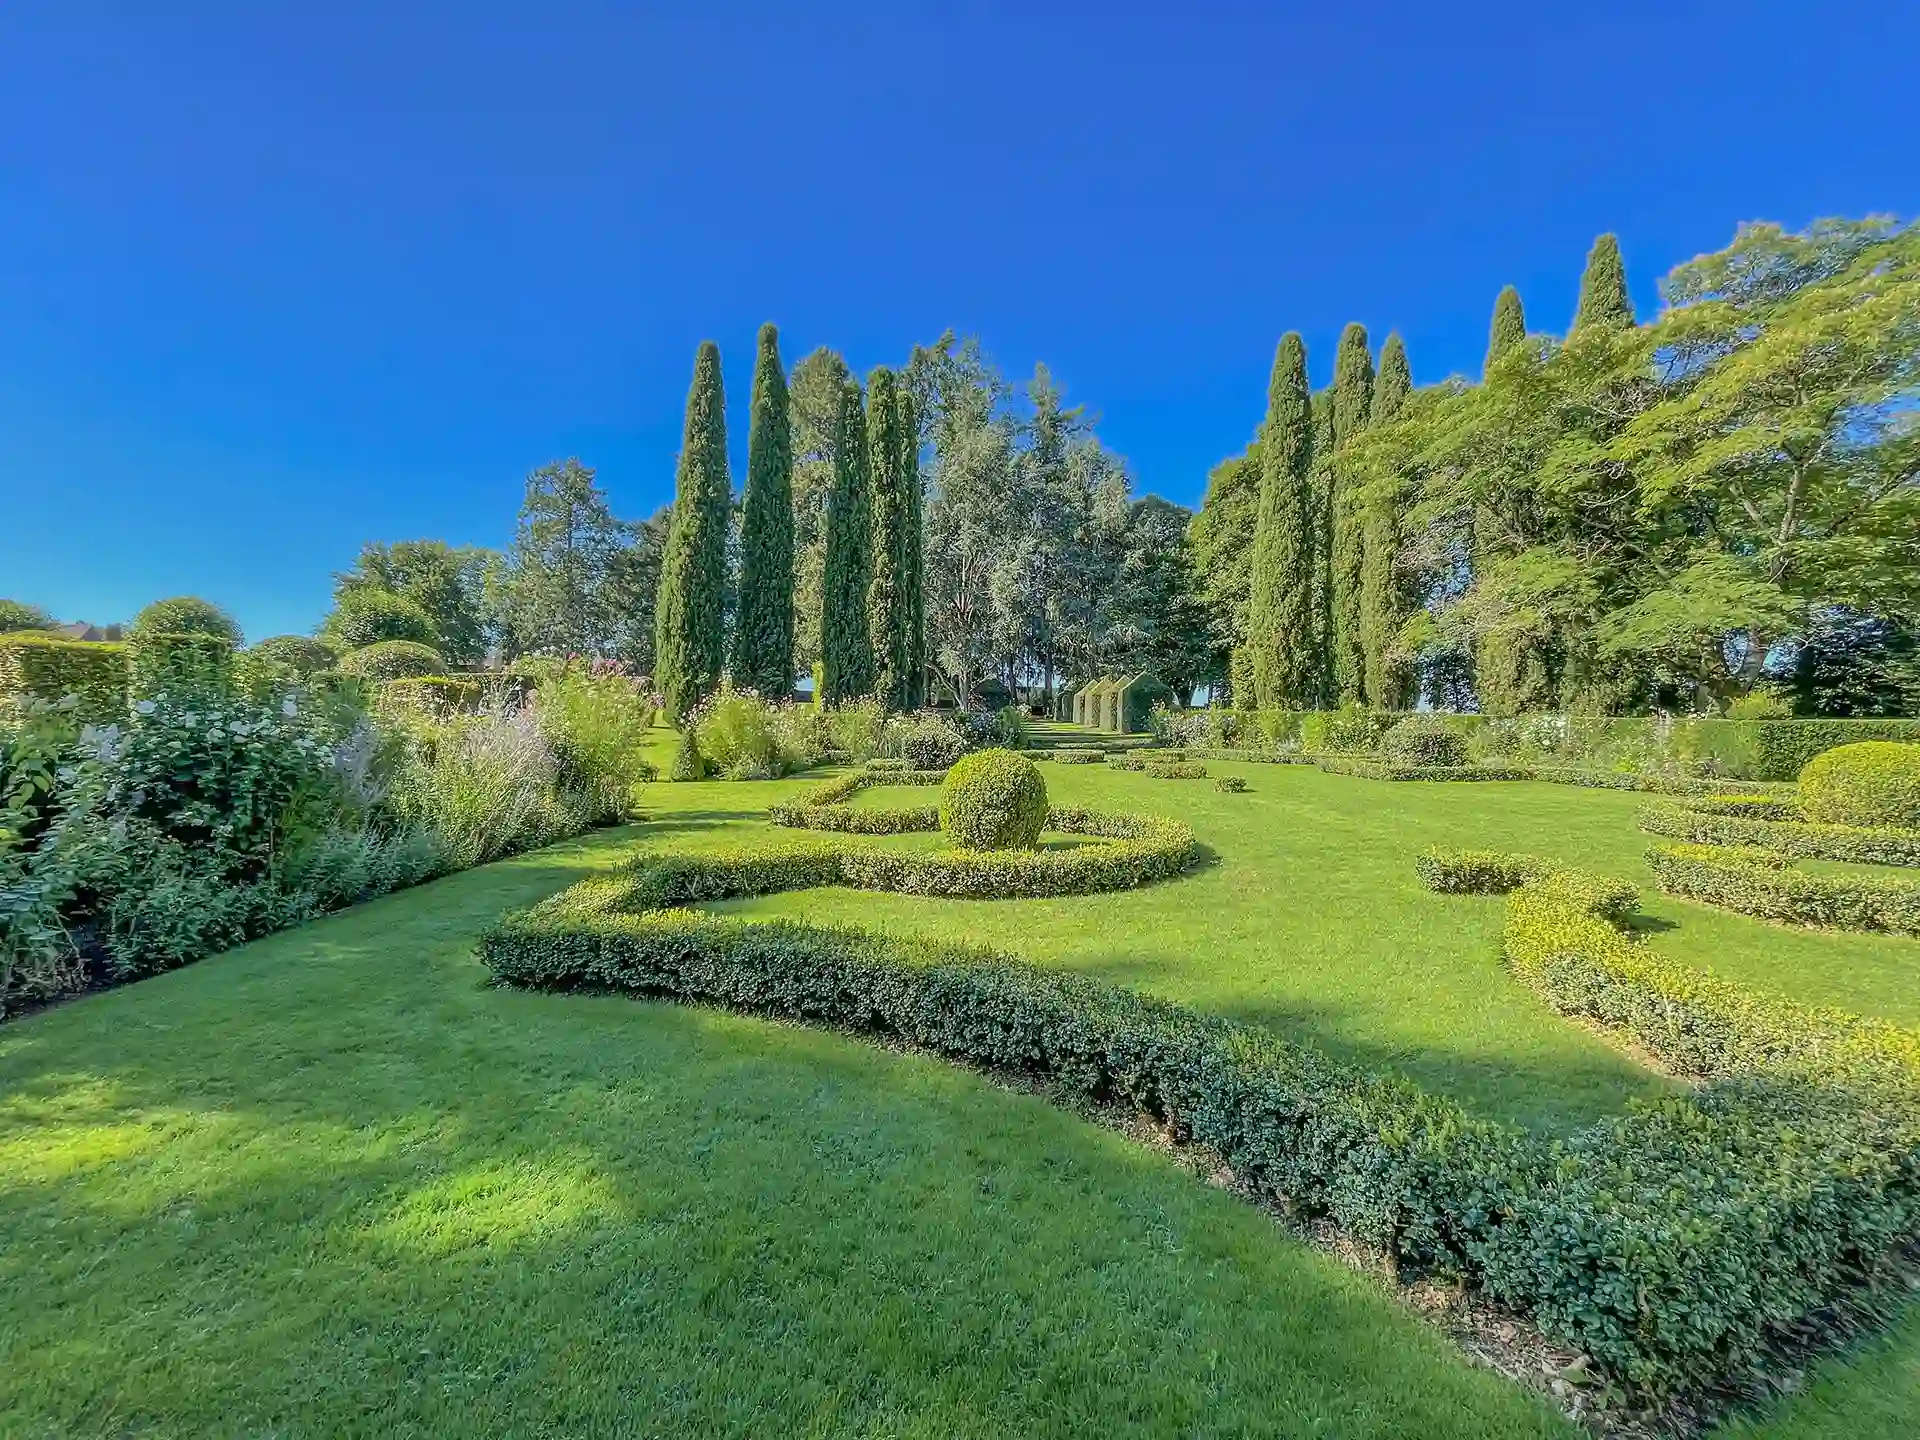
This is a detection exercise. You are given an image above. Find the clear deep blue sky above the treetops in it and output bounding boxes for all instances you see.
[0,0,1920,637]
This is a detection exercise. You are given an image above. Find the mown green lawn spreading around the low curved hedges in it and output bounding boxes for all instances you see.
[0,748,1920,1440]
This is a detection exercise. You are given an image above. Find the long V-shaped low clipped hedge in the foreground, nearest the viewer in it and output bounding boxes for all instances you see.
[482,847,1920,1396]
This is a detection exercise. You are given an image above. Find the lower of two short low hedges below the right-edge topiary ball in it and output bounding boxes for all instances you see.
[1647,845,1920,935]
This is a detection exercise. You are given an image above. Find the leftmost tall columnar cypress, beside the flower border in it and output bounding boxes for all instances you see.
[653,340,733,724]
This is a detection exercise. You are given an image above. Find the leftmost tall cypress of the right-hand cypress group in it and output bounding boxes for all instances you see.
[1246,330,1321,710]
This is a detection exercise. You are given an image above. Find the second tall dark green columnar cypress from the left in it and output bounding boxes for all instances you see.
[732,324,793,701]
